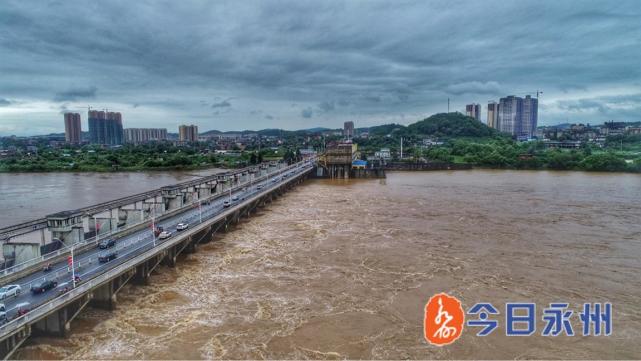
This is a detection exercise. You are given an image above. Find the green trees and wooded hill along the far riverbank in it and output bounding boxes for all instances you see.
[0,113,641,173]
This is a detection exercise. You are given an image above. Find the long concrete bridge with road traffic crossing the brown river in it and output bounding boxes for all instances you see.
[0,158,316,359]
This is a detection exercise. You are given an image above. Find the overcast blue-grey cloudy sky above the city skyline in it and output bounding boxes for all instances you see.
[0,0,641,135]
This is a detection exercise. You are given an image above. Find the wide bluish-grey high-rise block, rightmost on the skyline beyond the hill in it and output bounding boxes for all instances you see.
[498,95,539,138]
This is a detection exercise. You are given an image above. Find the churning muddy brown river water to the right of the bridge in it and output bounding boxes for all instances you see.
[8,170,641,359]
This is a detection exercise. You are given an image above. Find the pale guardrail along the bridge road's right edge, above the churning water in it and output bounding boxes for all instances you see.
[0,161,312,339]
